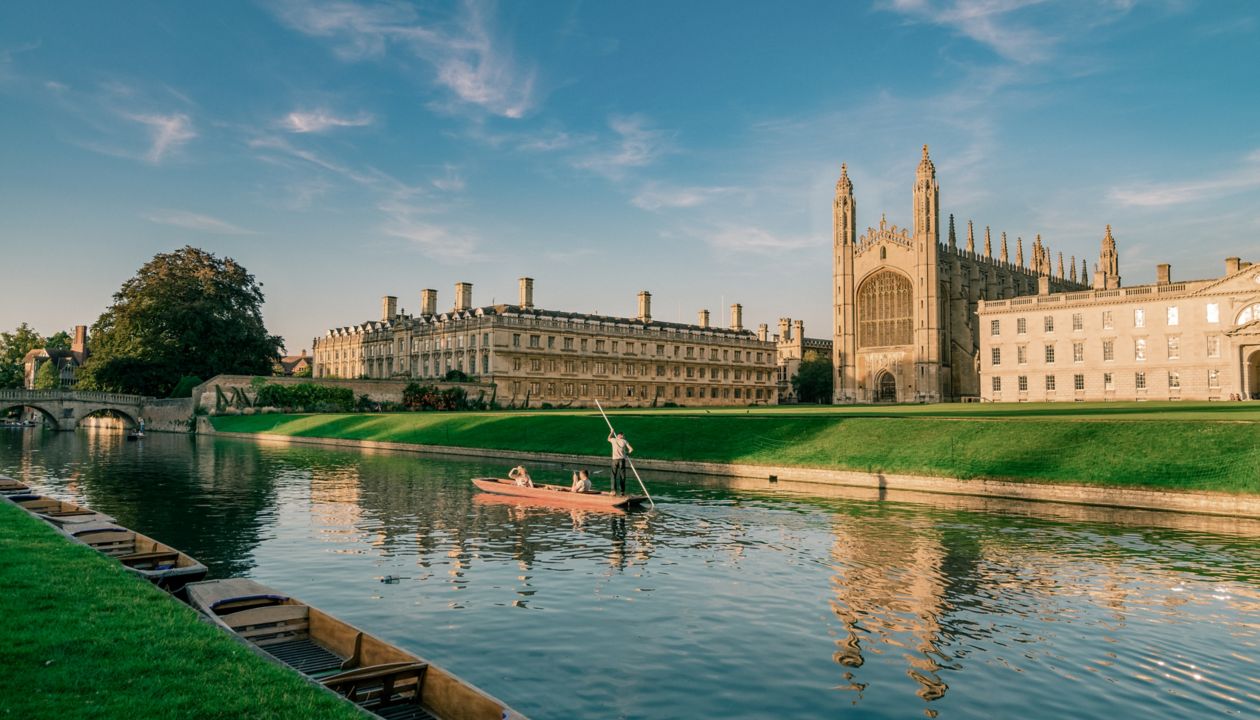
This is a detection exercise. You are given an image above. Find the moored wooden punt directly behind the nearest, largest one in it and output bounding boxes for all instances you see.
[62,522,205,593]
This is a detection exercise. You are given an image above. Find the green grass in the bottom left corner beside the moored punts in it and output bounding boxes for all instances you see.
[0,502,362,720]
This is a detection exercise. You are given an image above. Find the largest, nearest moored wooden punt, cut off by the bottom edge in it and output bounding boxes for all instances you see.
[186,578,524,720]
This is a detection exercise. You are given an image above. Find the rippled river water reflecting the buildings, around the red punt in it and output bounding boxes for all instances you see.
[0,430,1260,720]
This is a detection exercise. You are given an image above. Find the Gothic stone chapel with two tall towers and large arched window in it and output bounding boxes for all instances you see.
[833,145,1085,402]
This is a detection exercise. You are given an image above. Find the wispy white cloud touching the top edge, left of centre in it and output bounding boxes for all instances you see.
[276,0,536,117]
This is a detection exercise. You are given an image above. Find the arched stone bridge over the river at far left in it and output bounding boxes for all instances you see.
[0,390,193,430]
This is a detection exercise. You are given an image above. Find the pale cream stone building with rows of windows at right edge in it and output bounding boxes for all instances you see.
[979,250,1260,402]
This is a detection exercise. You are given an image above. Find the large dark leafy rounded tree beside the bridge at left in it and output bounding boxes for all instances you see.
[81,246,282,396]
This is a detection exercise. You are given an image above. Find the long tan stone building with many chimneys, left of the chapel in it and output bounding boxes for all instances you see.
[314,277,777,407]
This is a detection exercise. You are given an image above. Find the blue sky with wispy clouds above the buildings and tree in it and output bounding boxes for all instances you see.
[0,0,1260,353]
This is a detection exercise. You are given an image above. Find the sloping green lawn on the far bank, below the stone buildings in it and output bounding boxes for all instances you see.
[213,404,1260,493]
